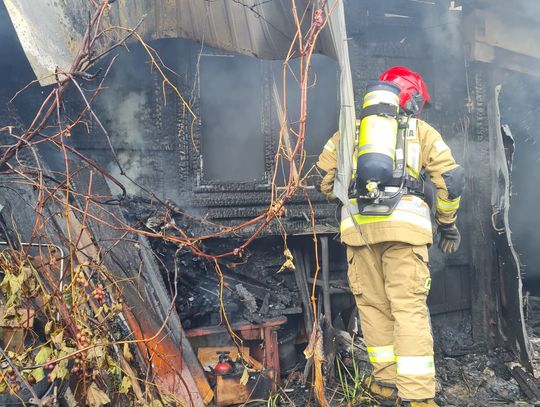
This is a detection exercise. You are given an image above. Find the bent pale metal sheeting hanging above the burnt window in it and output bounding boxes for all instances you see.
[4,0,336,85]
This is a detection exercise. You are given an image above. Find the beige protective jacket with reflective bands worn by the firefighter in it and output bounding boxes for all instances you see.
[317,119,464,246]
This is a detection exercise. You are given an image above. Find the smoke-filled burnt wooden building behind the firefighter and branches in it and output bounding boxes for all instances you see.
[0,0,540,406]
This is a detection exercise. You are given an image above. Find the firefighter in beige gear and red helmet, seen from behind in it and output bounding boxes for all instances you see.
[317,67,464,407]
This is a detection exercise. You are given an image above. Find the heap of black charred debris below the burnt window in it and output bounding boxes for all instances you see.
[125,197,302,329]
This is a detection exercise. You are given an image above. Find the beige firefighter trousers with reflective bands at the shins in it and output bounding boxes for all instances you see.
[347,242,435,400]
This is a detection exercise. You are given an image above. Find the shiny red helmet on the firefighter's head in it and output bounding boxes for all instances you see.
[379,66,431,115]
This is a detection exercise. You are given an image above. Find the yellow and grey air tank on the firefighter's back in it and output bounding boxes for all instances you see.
[356,81,400,191]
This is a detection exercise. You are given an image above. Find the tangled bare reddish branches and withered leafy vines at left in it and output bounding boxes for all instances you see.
[0,0,337,406]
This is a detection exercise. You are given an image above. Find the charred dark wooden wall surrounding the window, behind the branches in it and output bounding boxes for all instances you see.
[65,40,338,236]
